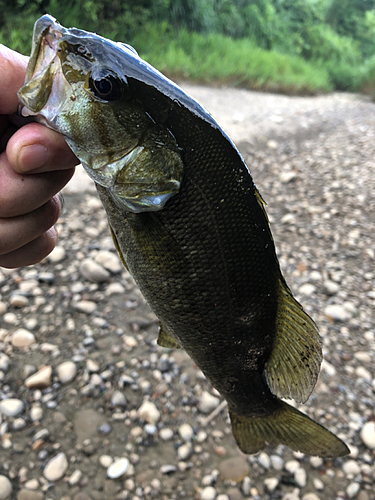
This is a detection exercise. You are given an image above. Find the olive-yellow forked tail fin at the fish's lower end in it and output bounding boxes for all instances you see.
[229,401,350,458]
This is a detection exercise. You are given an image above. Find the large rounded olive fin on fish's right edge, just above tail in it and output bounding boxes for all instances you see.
[265,279,322,403]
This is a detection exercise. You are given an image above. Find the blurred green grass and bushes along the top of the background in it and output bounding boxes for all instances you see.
[0,0,375,93]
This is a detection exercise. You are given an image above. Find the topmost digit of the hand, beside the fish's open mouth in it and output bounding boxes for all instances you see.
[0,44,28,115]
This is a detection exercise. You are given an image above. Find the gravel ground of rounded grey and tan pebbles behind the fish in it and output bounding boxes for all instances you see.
[0,85,375,500]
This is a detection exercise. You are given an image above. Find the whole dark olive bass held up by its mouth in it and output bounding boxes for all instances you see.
[18,15,349,457]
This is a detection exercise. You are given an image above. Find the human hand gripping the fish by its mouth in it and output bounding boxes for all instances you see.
[0,44,79,268]
